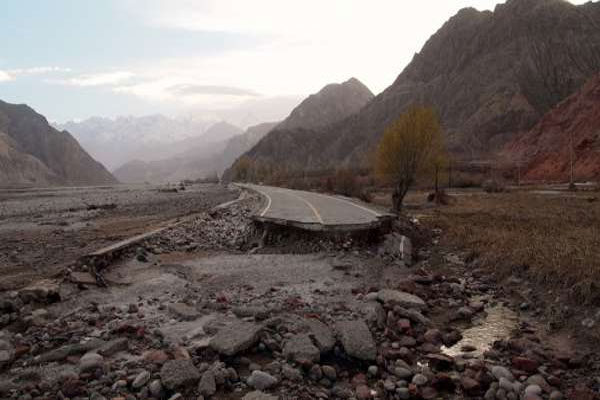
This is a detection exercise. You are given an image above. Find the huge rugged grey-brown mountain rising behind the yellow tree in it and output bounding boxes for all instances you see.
[233,0,600,170]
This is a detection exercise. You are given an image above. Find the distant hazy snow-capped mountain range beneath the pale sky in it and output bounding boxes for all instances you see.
[55,115,216,169]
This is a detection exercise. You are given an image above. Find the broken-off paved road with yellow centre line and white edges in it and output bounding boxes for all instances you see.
[241,185,389,228]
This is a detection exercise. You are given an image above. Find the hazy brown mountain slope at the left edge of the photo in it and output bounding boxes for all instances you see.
[0,101,117,186]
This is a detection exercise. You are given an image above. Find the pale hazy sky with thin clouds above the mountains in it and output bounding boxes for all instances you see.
[0,0,585,121]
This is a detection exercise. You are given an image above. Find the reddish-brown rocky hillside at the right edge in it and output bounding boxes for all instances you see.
[506,74,600,181]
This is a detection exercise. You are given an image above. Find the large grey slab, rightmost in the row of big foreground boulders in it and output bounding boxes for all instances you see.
[335,320,377,361]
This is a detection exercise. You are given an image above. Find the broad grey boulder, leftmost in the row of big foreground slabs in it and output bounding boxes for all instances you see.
[209,321,262,356]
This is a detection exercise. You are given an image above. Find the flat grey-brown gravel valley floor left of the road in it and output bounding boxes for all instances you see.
[0,185,235,291]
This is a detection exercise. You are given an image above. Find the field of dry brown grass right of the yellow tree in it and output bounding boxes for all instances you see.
[424,192,600,304]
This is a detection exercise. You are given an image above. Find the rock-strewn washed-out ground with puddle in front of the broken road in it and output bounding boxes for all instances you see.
[0,188,600,400]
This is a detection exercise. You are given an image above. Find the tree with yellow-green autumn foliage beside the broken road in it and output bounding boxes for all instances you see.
[375,106,445,213]
